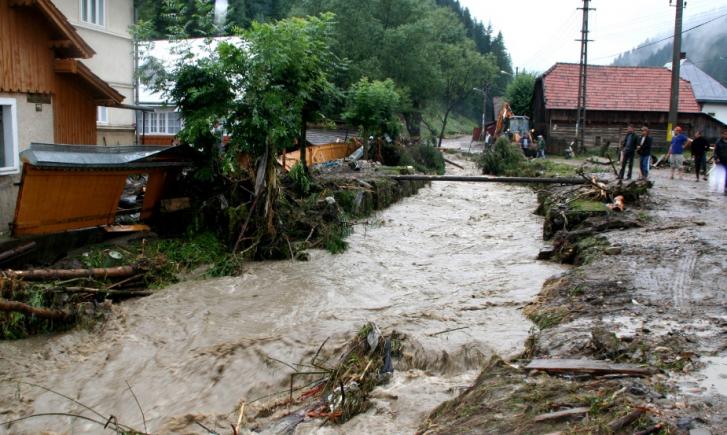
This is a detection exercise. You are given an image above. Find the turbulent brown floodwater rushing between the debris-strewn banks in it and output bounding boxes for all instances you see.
[0,158,562,433]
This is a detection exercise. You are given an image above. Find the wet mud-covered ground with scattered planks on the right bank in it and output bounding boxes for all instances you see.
[420,145,727,434]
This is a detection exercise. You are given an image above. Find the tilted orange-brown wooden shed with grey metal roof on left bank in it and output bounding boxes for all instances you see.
[12,143,192,236]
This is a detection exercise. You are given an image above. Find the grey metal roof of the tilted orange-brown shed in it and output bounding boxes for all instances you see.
[20,143,191,169]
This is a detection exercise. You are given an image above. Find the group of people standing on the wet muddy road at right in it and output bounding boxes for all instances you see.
[618,125,727,194]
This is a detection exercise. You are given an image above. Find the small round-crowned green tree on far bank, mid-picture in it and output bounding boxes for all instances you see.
[343,77,401,159]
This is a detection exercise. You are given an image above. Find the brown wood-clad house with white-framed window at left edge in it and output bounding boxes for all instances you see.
[0,0,124,236]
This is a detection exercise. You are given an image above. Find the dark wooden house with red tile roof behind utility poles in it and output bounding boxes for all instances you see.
[533,63,722,153]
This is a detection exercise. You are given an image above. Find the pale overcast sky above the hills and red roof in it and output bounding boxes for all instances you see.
[459,0,727,72]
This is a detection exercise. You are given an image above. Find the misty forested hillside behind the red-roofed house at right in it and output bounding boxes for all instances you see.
[614,16,727,86]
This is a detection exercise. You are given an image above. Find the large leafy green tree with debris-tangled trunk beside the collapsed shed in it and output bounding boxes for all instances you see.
[169,15,339,258]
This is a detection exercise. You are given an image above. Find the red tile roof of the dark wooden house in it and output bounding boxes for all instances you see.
[541,63,700,113]
